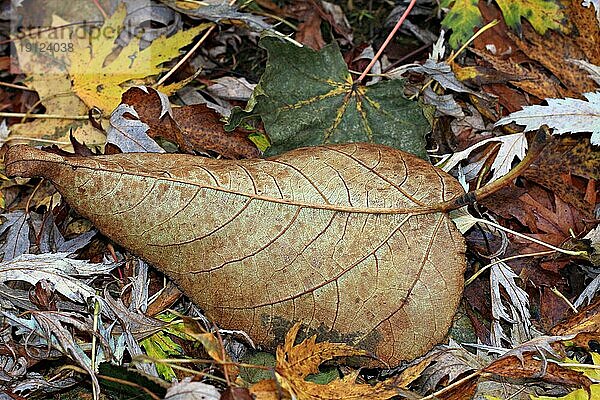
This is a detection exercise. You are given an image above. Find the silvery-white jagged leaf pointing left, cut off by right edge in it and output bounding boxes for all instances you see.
[495,92,600,145]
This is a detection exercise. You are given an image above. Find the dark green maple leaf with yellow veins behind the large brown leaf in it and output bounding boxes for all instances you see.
[228,37,429,158]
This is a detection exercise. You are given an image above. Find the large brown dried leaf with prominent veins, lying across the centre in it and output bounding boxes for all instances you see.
[6,144,465,364]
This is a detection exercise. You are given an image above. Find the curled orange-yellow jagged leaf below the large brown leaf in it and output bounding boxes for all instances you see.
[250,324,399,400]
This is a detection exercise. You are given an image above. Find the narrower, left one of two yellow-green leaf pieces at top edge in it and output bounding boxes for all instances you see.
[440,0,483,49]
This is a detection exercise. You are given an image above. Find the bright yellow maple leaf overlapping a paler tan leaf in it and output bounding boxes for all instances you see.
[69,5,212,113]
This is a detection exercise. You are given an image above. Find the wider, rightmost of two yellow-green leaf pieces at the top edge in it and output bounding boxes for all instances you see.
[496,0,565,35]
